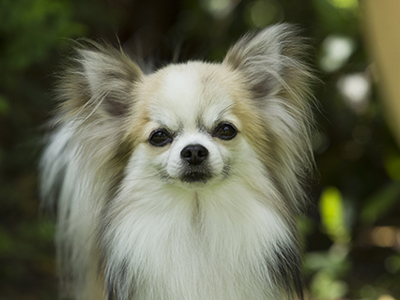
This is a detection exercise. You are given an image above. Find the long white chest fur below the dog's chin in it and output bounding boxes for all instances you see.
[103,178,291,300]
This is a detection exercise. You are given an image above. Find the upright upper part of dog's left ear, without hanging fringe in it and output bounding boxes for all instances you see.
[59,42,143,118]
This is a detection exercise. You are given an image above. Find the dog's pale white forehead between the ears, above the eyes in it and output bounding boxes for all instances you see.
[142,62,233,129]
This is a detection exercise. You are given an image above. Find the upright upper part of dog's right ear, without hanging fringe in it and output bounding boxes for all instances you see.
[224,24,312,98]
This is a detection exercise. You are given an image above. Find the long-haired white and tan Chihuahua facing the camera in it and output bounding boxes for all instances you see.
[41,24,313,300]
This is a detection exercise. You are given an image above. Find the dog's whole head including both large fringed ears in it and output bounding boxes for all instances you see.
[57,25,311,206]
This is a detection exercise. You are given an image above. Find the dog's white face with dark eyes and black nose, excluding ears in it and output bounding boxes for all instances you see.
[133,62,256,189]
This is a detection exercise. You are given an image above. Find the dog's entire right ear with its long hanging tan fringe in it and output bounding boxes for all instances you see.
[223,24,314,210]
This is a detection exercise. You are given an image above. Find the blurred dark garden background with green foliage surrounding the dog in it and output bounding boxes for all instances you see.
[0,0,400,300]
